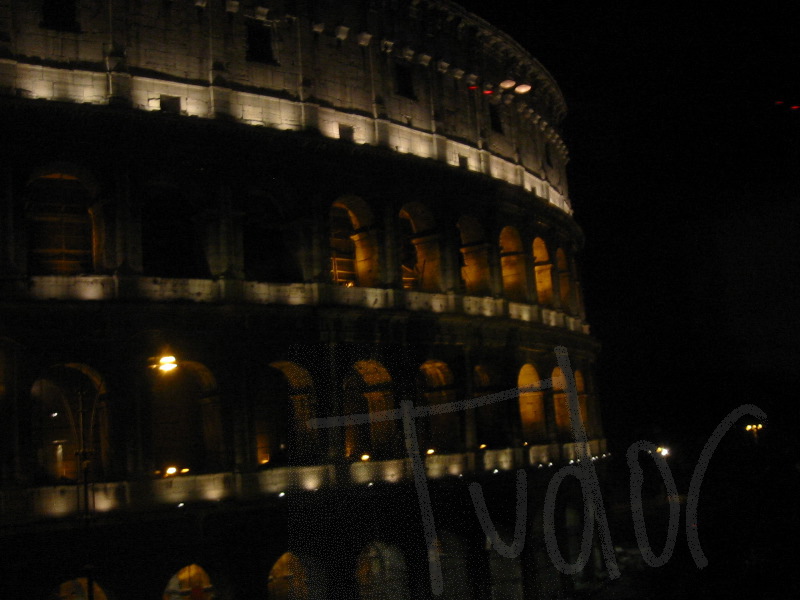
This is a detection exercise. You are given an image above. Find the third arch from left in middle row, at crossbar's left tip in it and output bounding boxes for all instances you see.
[252,361,319,466]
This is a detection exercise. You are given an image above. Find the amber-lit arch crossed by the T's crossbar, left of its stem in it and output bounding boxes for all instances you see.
[344,360,398,460]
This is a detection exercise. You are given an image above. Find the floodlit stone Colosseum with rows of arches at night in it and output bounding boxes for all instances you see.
[0,0,607,600]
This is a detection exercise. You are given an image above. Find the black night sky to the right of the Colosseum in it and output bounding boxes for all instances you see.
[461,0,800,444]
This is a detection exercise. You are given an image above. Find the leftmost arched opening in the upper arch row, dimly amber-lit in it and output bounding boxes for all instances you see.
[25,172,97,275]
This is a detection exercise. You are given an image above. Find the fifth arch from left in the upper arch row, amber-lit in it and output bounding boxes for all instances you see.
[399,202,441,292]
